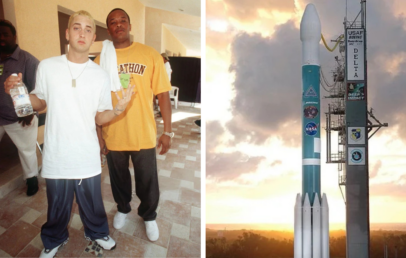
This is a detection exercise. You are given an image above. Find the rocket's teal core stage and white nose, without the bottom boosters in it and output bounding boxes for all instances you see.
[300,1,321,205]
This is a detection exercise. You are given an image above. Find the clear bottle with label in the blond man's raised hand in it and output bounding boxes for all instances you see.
[10,73,34,117]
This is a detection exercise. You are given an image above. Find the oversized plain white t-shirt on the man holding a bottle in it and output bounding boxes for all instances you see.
[31,55,112,179]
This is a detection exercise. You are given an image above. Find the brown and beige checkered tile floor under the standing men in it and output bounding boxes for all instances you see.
[0,106,201,257]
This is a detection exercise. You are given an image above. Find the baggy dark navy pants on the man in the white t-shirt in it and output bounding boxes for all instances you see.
[41,175,109,249]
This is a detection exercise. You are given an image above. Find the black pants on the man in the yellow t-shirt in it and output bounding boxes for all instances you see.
[107,148,159,221]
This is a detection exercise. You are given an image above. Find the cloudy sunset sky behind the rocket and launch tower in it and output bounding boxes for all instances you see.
[205,0,406,229]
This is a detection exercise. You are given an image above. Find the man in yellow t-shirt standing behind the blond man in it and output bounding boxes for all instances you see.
[95,8,174,241]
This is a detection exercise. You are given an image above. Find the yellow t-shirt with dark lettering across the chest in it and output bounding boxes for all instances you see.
[95,42,171,151]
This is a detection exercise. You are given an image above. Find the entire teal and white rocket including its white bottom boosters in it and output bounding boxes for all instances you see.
[294,4,330,258]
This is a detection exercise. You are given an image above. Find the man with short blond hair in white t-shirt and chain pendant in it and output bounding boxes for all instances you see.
[5,11,134,257]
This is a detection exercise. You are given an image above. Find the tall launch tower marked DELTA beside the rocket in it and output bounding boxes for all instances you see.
[320,0,388,258]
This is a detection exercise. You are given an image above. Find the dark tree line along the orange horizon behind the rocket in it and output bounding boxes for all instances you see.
[206,229,406,258]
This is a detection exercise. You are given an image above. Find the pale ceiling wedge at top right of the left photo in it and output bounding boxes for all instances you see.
[139,0,201,17]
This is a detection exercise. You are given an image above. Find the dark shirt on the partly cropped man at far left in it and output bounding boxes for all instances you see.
[0,46,39,126]
